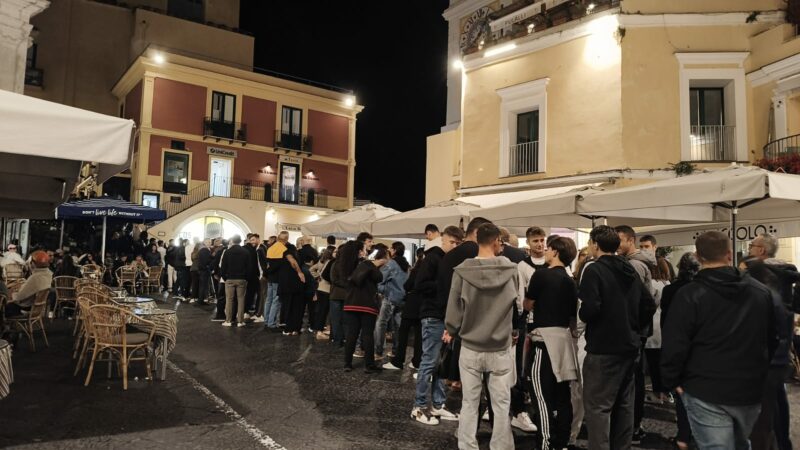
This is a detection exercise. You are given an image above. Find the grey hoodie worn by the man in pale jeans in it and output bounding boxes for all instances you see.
[445,256,519,352]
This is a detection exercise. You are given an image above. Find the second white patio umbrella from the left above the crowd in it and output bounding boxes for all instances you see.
[372,200,478,239]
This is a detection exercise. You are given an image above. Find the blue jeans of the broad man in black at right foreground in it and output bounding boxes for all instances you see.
[681,392,761,450]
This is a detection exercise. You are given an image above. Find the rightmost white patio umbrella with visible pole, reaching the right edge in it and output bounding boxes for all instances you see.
[579,166,800,264]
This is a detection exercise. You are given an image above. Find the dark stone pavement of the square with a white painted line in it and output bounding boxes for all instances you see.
[0,298,800,450]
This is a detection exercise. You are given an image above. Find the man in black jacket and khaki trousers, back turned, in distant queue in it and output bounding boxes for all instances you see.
[220,234,250,327]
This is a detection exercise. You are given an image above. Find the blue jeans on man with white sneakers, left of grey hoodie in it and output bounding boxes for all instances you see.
[414,317,447,408]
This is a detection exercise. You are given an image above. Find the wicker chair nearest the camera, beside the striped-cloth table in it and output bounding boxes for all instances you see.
[84,305,155,390]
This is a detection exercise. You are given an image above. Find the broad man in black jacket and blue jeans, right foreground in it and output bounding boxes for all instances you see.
[661,231,777,449]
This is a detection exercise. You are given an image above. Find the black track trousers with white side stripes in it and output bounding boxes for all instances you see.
[531,342,572,450]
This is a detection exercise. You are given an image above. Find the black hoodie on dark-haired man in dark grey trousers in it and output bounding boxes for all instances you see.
[578,255,656,357]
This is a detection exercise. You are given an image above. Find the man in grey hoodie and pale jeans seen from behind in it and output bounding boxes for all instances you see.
[443,223,519,450]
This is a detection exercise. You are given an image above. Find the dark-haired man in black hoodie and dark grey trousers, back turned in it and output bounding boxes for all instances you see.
[578,225,656,449]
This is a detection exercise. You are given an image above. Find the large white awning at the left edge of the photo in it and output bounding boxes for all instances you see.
[0,90,134,219]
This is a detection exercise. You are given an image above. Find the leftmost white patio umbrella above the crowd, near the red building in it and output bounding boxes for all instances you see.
[300,203,399,238]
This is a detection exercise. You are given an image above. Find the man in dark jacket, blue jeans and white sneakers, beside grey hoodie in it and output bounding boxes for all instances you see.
[411,226,464,425]
